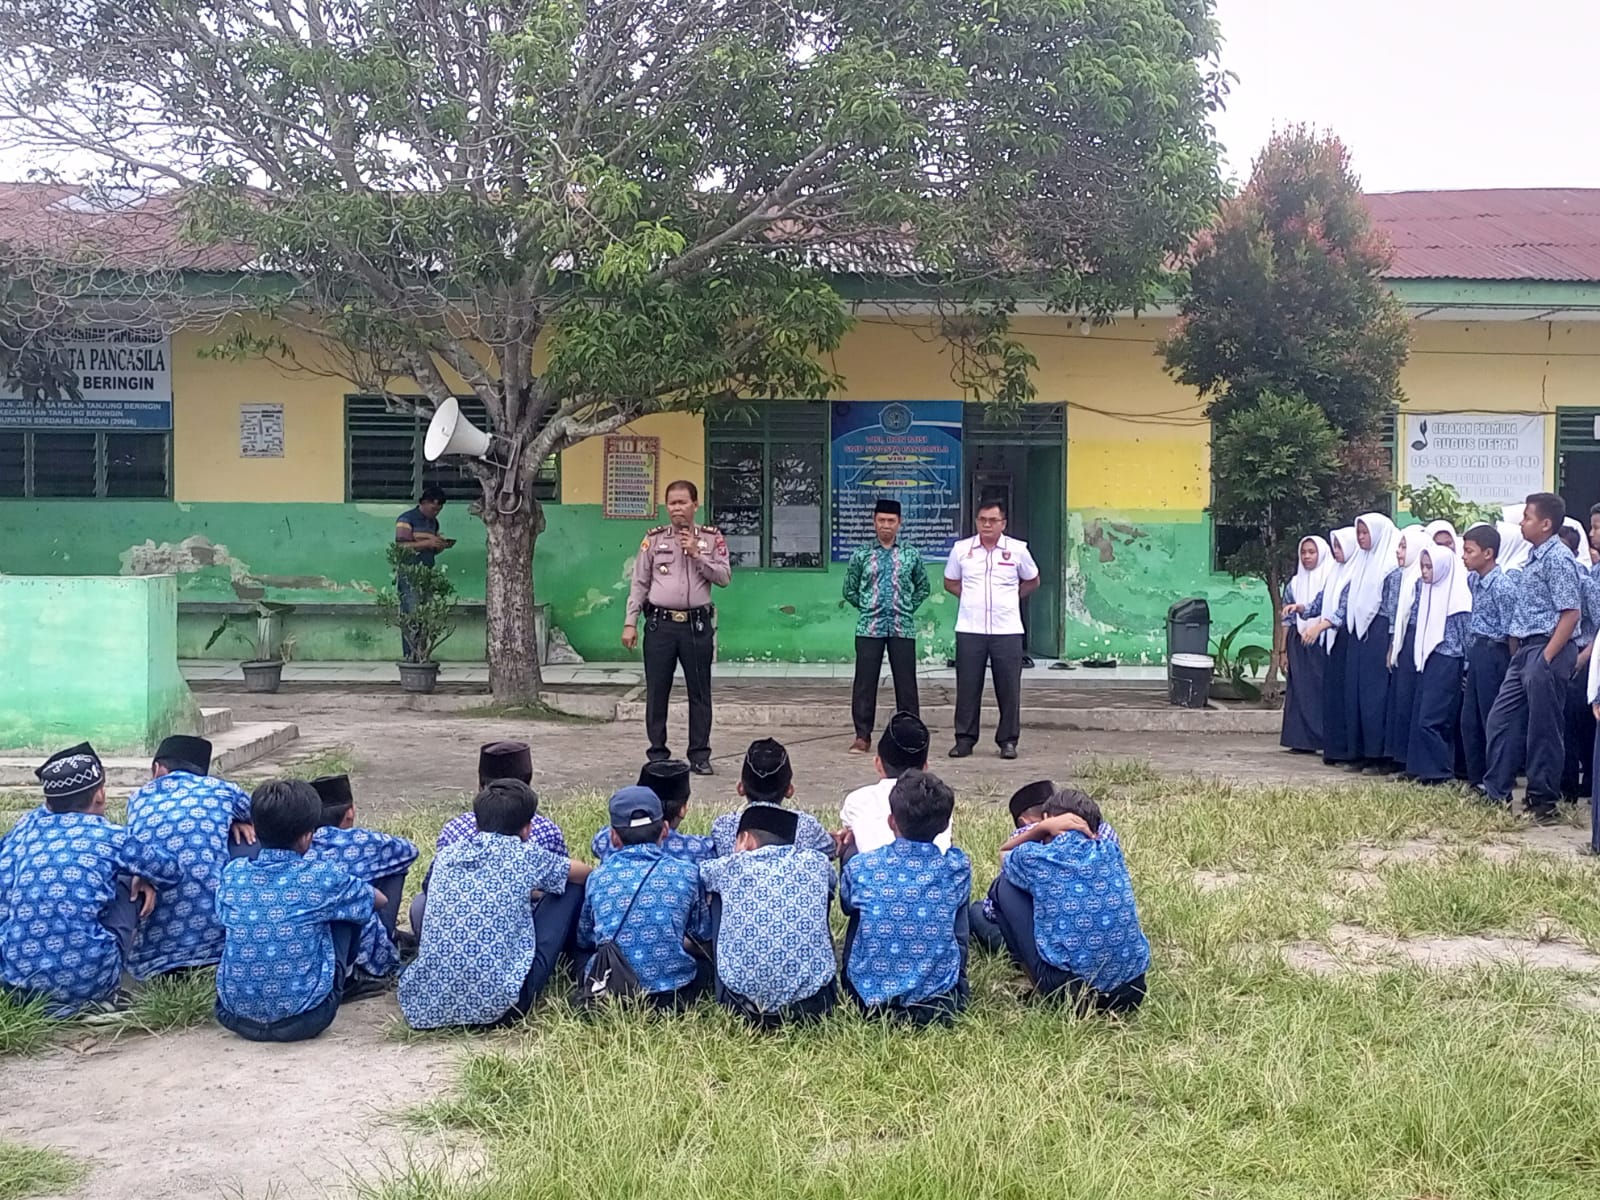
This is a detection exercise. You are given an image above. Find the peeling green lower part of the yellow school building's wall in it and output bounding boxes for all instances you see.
[0,501,1267,662]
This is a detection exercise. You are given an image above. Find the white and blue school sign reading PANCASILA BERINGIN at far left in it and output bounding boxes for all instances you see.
[0,330,173,429]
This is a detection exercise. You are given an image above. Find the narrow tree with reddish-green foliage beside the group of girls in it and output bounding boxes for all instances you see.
[1162,128,1408,683]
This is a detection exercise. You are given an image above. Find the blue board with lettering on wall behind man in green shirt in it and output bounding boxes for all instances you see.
[829,400,962,563]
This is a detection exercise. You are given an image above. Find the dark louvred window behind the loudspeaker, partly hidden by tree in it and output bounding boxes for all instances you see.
[344,395,562,504]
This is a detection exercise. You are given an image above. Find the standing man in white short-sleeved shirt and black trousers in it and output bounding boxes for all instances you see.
[944,501,1038,758]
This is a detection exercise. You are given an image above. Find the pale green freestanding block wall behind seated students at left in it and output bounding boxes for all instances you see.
[0,576,200,754]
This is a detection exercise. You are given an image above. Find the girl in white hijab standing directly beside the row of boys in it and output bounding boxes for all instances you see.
[1406,546,1472,784]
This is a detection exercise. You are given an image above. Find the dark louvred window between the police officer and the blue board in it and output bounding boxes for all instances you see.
[706,400,829,570]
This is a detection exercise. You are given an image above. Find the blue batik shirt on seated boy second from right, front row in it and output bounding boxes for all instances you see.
[838,837,973,1005]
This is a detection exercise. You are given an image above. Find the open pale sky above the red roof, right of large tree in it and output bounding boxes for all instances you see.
[1216,0,1600,192]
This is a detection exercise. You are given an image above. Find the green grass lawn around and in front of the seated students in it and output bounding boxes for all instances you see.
[9,763,1600,1200]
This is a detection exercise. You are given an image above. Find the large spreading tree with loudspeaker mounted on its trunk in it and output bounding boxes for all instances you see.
[0,0,1224,701]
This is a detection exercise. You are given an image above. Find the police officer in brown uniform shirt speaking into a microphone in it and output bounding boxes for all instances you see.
[622,480,733,774]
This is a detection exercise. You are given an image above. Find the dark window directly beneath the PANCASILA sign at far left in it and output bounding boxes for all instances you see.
[0,429,173,499]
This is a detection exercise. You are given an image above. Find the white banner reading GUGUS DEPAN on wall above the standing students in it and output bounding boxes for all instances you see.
[1405,413,1546,504]
